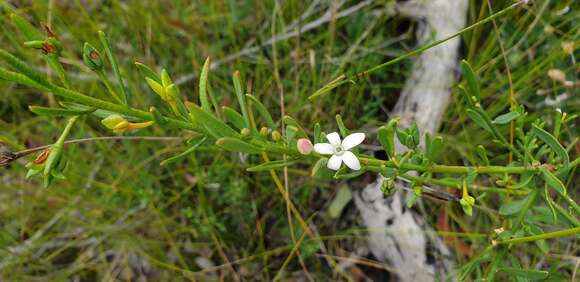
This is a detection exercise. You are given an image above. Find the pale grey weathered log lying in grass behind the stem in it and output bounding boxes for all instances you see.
[355,0,467,281]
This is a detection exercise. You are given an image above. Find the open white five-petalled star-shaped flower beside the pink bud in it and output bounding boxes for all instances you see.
[314,132,365,170]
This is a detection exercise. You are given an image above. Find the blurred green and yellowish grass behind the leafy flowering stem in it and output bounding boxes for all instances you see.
[0,0,580,281]
